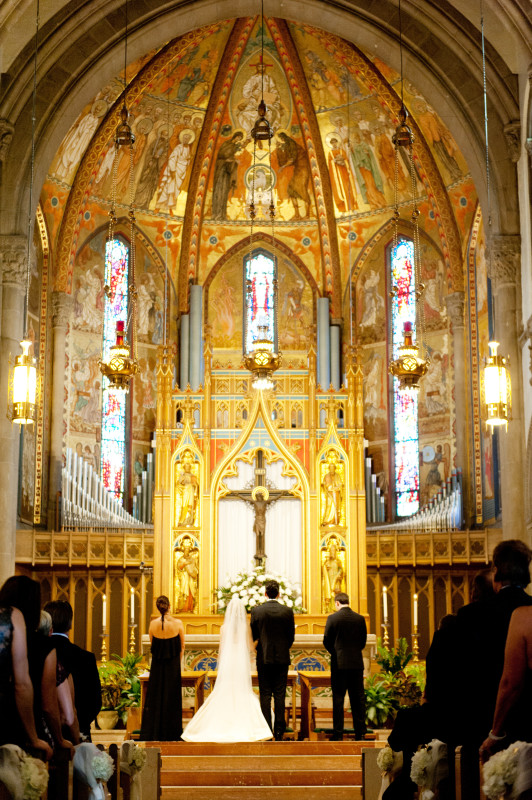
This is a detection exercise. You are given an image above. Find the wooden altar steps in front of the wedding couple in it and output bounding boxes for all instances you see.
[147,741,378,800]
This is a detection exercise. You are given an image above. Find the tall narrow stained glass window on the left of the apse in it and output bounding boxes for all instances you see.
[101,239,129,500]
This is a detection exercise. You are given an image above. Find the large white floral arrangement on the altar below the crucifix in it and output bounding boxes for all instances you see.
[217,567,306,614]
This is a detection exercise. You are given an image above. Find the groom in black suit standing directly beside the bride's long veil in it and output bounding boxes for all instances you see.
[251,581,295,741]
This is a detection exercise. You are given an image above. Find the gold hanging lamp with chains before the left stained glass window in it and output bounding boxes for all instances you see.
[98,0,139,392]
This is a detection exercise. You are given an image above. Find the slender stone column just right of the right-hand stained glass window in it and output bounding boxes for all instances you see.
[445,292,473,528]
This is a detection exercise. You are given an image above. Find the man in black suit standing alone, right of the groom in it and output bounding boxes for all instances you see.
[323,592,367,741]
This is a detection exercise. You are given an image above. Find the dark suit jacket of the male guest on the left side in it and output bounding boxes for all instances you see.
[52,634,102,736]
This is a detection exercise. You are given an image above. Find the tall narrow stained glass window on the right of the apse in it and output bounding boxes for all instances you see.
[390,239,419,517]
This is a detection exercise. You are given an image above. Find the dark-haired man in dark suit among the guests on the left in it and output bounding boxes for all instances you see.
[45,600,102,741]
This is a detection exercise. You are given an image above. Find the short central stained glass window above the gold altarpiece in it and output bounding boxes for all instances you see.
[245,252,275,353]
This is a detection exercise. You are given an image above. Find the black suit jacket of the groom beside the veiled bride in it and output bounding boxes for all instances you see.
[251,600,296,666]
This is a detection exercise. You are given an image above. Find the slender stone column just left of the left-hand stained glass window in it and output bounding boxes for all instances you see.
[48,292,72,531]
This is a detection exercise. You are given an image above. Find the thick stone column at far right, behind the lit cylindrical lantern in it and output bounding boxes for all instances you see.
[488,235,526,539]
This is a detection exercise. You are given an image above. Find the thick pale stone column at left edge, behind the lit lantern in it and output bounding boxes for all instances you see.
[0,235,27,585]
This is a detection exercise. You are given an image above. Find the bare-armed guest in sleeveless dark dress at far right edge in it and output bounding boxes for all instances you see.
[480,606,532,761]
